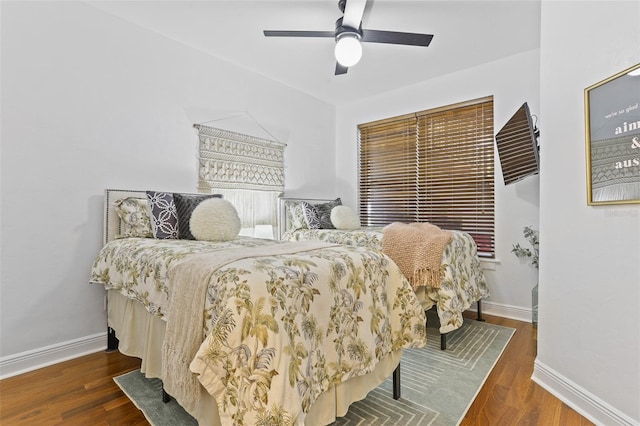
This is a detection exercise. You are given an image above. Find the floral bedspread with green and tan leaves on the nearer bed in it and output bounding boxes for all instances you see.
[90,238,426,425]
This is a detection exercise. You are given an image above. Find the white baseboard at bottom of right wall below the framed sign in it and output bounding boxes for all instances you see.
[531,359,640,426]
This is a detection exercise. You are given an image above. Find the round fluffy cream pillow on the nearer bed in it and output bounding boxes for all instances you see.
[189,198,241,241]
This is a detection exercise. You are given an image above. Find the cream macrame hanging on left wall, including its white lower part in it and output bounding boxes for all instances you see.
[193,124,286,228]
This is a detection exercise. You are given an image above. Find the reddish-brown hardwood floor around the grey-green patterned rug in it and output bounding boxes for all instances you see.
[0,312,592,426]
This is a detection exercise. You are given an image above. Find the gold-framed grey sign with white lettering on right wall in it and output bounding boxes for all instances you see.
[584,64,640,205]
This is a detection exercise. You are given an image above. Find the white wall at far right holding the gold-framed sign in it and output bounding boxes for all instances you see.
[534,1,640,425]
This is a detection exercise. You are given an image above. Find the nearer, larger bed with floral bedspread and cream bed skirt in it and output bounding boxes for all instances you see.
[89,189,426,425]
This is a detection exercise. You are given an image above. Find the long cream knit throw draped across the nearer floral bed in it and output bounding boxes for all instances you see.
[162,241,336,414]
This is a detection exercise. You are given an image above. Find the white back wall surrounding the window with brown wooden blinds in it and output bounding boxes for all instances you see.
[336,49,546,321]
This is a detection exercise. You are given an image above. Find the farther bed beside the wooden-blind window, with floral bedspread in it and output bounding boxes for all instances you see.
[278,197,489,349]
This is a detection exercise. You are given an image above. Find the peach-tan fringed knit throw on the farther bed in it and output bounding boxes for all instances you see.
[382,222,453,289]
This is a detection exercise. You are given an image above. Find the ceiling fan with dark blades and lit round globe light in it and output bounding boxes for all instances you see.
[264,0,433,75]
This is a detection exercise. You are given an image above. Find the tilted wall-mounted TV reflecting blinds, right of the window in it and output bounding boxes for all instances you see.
[496,102,540,185]
